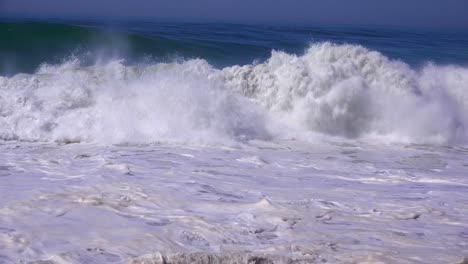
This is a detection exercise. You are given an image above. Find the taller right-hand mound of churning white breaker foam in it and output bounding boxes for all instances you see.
[224,43,468,144]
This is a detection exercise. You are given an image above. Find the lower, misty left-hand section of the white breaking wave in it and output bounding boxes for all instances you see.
[0,60,268,143]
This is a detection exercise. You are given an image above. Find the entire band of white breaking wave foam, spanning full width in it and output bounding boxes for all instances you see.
[0,43,468,145]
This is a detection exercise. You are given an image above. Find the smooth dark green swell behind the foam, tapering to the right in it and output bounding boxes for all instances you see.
[0,21,249,75]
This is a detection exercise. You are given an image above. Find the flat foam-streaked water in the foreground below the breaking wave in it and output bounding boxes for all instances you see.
[0,141,468,263]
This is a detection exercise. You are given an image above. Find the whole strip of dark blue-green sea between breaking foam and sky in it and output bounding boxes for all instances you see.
[0,19,468,74]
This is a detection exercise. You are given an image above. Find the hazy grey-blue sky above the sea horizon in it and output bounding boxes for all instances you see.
[0,0,468,28]
